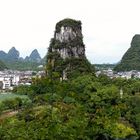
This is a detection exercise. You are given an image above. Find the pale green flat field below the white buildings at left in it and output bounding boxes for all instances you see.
[0,93,29,102]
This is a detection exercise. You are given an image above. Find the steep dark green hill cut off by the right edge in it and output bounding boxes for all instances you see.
[114,34,140,71]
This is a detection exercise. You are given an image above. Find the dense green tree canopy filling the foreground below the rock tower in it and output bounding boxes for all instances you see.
[0,75,140,140]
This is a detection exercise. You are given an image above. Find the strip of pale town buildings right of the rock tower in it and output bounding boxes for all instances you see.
[96,69,140,79]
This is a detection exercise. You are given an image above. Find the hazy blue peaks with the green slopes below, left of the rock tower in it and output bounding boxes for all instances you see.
[0,47,45,70]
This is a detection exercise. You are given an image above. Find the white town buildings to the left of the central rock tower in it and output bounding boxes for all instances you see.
[0,70,44,90]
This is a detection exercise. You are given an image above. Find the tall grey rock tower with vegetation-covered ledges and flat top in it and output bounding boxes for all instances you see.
[47,19,91,79]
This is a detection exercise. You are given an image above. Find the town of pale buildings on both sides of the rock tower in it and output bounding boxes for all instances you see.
[0,68,140,91]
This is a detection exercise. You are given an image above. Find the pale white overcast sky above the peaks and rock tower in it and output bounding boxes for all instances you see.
[0,0,140,64]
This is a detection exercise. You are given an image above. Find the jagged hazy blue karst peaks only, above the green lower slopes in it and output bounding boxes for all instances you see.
[0,47,42,63]
